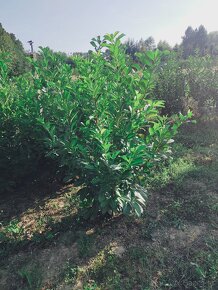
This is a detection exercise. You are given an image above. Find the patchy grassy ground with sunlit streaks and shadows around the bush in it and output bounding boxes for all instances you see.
[0,121,218,290]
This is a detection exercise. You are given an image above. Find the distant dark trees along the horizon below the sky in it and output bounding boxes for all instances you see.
[0,23,218,75]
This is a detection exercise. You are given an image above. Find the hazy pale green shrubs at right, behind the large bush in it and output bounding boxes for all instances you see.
[154,53,218,117]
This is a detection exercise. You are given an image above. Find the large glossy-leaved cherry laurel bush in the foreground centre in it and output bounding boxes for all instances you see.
[38,32,191,217]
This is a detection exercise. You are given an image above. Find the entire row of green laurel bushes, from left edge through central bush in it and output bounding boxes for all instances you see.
[0,33,190,216]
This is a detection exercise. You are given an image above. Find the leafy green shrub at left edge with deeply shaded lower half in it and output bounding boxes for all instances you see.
[0,50,57,191]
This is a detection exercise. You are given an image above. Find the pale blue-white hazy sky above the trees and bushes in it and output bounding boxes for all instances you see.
[0,0,218,53]
